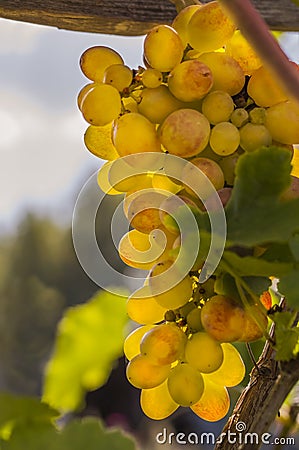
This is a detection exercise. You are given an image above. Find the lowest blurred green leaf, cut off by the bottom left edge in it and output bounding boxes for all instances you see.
[3,419,136,450]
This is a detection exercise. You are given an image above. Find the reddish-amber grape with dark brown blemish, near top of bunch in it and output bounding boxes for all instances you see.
[168,59,213,102]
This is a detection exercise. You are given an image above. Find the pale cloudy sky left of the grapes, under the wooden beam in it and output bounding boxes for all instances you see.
[0,19,299,231]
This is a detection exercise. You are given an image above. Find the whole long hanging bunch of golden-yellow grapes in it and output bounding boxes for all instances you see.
[78,1,299,421]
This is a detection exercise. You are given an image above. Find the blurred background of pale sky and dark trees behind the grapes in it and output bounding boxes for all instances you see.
[0,19,299,449]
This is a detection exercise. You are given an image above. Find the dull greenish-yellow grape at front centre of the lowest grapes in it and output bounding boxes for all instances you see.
[167,363,204,406]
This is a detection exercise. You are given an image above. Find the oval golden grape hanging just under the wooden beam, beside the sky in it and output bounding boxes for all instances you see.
[144,25,184,72]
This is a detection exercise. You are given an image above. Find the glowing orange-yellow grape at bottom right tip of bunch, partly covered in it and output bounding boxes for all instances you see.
[191,375,230,422]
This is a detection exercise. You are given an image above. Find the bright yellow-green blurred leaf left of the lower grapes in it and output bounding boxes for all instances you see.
[43,291,127,411]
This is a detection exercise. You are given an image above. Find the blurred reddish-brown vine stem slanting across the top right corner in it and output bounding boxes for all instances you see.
[219,0,299,104]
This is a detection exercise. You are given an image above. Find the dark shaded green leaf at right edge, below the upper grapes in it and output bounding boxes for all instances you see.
[226,146,299,246]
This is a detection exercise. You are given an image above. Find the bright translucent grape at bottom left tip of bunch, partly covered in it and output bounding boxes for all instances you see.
[140,381,179,420]
